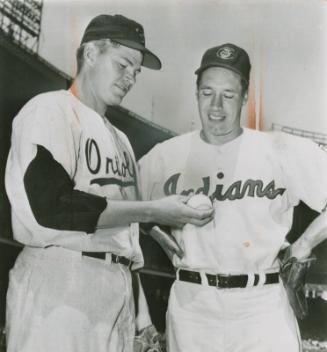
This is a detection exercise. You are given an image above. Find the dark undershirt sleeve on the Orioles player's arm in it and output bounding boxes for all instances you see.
[24,145,107,233]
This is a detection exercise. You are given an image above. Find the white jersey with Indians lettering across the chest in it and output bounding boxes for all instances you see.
[139,128,327,274]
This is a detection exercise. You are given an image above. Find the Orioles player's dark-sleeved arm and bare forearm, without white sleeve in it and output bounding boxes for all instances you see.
[24,146,213,233]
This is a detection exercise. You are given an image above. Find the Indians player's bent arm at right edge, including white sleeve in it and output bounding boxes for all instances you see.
[276,134,327,259]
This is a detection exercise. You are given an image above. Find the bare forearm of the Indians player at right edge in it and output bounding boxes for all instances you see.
[291,208,327,259]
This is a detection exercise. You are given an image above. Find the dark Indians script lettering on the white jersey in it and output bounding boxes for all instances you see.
[164,172,285,201]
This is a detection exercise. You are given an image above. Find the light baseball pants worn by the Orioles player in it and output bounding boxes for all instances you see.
[6,247,135,352]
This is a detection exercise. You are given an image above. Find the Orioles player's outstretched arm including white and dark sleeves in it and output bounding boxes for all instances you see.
[19,103,212,233]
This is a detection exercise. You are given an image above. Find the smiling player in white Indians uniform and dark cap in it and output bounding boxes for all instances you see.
[139,44,327,352]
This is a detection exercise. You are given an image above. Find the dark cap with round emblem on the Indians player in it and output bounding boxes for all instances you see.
[195,43,251,83]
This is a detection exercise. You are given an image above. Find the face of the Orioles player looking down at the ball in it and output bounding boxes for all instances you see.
[85,43,142,110]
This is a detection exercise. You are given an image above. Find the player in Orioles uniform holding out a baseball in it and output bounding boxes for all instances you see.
[6,15,212,352]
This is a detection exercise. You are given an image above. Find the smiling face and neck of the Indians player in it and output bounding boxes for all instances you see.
[197,67,247,144]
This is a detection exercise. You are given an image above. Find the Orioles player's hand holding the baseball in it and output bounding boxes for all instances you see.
[152,195,214,228]
